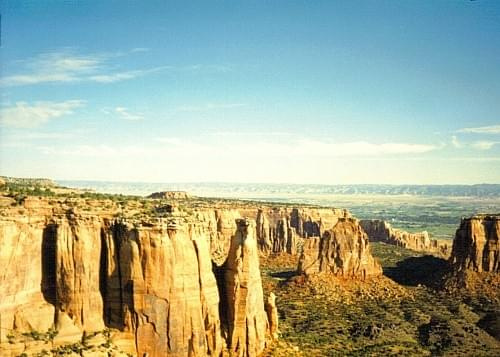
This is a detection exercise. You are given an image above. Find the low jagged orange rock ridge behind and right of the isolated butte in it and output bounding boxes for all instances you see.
[360,219,451,258]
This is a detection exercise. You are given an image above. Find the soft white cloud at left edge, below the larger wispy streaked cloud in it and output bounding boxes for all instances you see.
[0,100,85,128]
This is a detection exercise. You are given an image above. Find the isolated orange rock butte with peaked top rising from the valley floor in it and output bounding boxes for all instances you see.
[297,218,382,279]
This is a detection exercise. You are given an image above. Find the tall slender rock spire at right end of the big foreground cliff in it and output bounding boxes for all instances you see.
[224,219,268,357]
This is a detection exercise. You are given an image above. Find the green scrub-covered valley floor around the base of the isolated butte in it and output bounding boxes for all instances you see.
[262,243,500,356]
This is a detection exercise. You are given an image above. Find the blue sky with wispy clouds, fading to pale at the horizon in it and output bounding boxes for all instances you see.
[0,0,500,184]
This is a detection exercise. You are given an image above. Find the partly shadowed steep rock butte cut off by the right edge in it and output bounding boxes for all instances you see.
[450,214,500,273]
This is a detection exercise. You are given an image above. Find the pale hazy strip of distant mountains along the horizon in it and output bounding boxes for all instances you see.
[57,180,500,198]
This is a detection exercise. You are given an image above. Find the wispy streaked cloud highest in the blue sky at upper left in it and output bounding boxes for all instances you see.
[0,49,172,87]
